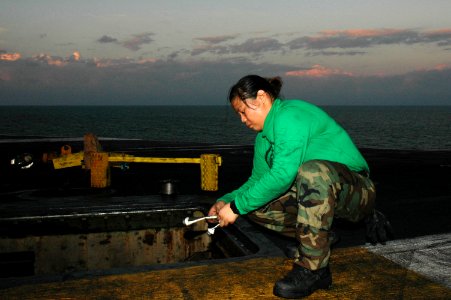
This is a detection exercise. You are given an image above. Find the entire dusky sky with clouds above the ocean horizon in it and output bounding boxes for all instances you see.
[0,0,451,105]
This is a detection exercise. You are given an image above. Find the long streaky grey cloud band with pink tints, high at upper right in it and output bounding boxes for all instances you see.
[187,28,451,57]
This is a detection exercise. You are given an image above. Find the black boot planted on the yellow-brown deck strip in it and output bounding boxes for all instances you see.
[273,264,332,298]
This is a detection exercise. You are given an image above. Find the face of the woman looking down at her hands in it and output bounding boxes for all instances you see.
[231,91,272,131]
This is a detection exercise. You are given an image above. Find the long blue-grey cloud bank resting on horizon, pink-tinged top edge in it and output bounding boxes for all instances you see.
[0,52,451,105]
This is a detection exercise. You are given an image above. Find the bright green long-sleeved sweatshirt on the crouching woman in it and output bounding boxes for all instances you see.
[218,99,369,214]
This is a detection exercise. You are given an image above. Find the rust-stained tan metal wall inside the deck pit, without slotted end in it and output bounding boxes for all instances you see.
[0,224,212,276]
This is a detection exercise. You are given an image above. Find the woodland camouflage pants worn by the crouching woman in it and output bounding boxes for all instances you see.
[248,160,376,270]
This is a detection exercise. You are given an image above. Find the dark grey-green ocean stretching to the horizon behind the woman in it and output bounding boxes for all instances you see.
[0,106,451,150]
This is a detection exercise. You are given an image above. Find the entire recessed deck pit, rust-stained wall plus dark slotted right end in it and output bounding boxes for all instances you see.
[0,216,283,289]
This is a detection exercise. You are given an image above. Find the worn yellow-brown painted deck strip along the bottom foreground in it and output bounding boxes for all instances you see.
[0,247,451,299]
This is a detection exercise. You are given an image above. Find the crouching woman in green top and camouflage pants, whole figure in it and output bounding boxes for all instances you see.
[209,75,386,297]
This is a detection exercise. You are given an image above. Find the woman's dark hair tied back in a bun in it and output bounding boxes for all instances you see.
[229,75,282,102]
